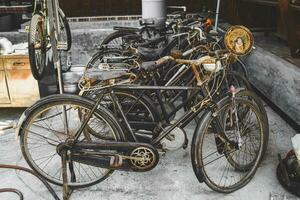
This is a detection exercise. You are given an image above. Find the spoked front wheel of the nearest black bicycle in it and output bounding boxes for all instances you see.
[192,97,266,193]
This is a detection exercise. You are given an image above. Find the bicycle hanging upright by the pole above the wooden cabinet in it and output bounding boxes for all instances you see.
[28,0,72,80]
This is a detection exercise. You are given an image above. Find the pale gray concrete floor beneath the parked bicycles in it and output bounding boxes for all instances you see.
[0,107,296,200]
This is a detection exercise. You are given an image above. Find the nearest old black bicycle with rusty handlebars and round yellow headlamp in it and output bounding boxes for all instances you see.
[17,27,268,198]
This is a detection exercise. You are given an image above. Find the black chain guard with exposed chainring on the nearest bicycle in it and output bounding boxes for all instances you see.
[57,141,159,172]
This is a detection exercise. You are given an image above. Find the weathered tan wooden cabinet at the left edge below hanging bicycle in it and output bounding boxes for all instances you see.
[0,55,40,107]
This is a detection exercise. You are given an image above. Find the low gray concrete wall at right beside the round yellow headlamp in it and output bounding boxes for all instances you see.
[246,47,300,125]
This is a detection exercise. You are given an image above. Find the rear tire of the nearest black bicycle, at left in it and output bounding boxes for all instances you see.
[19,94,125,189]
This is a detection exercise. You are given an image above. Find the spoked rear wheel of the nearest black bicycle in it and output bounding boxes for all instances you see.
[20,95,122,188]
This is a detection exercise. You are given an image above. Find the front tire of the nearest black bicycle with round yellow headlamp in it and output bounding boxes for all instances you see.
[191,97,265,193]
